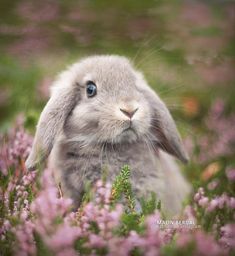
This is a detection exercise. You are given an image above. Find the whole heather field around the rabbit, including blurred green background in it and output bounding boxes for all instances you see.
[0,0,235,256]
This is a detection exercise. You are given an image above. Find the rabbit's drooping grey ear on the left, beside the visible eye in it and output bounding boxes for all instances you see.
[25,72,79,170]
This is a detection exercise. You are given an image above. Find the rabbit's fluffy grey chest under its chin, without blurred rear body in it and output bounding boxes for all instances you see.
[50,135,165,204]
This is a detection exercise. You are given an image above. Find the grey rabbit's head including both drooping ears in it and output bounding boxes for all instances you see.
[26,56,187,169]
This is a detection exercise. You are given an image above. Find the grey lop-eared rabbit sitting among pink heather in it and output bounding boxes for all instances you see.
[26,55,191,215]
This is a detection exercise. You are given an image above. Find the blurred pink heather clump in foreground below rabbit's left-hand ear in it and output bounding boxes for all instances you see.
[26,169,81,255]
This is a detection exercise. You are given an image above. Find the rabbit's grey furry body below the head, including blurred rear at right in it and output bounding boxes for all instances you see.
[50,134,191,215]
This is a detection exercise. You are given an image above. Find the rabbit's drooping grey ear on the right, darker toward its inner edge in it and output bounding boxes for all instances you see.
[138,74,189,163]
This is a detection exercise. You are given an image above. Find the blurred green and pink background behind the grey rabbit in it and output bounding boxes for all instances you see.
[0,0,235,180]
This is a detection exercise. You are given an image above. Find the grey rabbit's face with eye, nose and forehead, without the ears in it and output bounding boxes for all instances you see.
[65,56,151,144]
